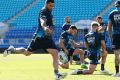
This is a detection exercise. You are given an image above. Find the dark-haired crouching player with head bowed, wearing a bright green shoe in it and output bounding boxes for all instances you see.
[59,25,87,69]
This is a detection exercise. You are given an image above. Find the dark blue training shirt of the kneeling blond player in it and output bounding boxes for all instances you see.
[85,31,104,56]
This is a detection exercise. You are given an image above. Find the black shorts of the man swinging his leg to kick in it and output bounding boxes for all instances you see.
[27,36,57,52]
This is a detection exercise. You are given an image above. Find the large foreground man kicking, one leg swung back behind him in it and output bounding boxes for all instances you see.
[3,0,67,80]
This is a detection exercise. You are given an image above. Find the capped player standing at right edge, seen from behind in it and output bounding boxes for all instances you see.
[107,0,120,77]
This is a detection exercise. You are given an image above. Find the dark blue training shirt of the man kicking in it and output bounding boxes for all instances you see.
[37,7,54,38]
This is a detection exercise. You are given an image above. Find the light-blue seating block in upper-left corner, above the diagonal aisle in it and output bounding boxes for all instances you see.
[0,0,32,22]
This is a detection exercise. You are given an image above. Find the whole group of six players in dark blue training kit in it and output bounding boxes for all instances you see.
[1,0,120,80]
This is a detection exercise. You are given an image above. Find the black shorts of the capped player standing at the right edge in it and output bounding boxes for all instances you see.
[112,34,120,49]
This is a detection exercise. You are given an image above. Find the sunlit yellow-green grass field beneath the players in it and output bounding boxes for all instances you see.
[0,54,120,80]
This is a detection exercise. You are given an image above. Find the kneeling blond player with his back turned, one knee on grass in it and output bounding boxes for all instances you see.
[71,22,106,75]
